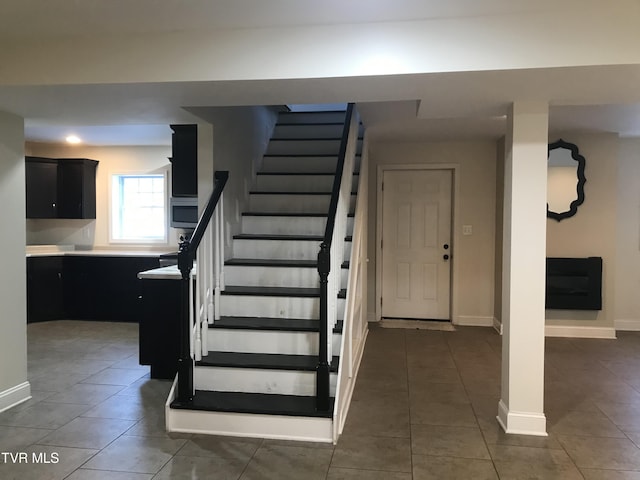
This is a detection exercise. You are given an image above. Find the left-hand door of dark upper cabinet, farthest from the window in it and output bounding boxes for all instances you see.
[25,157,58,218]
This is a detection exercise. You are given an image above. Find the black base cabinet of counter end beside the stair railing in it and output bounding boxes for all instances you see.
[139,279,181,380]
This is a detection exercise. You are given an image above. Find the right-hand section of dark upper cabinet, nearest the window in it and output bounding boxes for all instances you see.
[58,159,98,218]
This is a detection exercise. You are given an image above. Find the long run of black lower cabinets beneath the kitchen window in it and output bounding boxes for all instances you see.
[27,255,159,322]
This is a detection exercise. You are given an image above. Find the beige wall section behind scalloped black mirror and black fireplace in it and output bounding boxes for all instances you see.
[546,132,620,329]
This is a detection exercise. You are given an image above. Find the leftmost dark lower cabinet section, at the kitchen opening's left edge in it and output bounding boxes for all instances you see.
[27,256,65,323]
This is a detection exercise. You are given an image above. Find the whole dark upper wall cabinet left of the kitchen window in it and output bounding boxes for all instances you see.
[25,157,98,218]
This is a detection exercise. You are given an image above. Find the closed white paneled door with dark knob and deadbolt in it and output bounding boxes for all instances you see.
[381,170,452,320]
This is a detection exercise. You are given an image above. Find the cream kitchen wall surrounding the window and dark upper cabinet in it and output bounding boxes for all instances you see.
[26,140,181,250]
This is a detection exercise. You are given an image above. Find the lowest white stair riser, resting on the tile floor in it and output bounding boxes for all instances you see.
[165,408,333,443]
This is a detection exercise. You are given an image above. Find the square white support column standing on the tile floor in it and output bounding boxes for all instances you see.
[498,102,549,436]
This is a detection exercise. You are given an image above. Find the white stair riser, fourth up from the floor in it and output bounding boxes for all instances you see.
[220,295,344,319]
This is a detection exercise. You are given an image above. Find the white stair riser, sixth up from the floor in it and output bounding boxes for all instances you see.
[233,238,351,260]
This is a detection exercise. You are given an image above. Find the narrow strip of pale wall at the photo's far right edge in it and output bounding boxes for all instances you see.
[615,138,640,330]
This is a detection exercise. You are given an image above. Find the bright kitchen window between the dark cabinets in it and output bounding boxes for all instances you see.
[110,174,167,243]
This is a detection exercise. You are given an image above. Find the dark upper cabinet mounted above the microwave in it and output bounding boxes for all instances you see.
[169,125,198,197]
